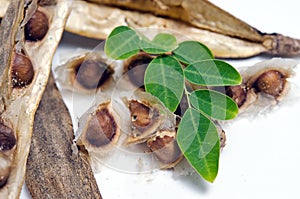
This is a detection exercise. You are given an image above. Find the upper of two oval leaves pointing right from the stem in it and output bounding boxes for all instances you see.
[184,59,242,86]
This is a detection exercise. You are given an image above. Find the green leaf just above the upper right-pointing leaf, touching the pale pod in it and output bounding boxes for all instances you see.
[173,41,213,64]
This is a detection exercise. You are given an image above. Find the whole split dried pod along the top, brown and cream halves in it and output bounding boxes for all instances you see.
[0,0,299,58]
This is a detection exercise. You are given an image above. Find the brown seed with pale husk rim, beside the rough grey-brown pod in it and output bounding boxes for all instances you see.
[76,102,120,154]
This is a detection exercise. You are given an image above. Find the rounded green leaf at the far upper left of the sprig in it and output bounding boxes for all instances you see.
[104,26,140,60]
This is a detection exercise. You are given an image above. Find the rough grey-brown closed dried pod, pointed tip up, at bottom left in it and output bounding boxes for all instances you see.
[26,76,102,199]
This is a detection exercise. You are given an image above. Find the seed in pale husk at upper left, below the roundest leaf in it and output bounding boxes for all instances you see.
[55,53,114,93]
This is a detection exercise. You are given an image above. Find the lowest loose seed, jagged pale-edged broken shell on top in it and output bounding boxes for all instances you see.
[147,130,183,169]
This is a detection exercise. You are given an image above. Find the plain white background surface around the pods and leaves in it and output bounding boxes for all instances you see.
[21,0,300,199]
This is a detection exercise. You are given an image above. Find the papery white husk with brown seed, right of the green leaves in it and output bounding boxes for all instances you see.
[227,58,299,116]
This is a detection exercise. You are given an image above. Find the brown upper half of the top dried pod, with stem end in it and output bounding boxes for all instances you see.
[88,0,300,56]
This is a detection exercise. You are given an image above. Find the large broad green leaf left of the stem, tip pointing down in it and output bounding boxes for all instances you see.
[144,56,184,112]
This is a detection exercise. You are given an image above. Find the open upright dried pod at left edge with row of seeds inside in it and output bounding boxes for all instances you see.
[0,0,69,198]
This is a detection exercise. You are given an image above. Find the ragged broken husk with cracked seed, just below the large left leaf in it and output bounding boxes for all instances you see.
[126,92,176,144]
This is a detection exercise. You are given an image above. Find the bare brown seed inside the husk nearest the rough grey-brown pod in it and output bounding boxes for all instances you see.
[85,108,117,147]
